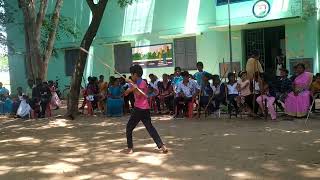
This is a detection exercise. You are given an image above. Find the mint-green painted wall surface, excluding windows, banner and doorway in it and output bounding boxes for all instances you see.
[8,0,319,88]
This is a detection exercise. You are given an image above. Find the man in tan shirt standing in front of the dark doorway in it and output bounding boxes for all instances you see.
[246,50,263,81]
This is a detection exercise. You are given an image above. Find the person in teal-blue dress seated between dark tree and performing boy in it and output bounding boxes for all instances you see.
[107,78,124,117]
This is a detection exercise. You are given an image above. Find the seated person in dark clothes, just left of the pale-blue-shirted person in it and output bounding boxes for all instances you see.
[158,74,174,113]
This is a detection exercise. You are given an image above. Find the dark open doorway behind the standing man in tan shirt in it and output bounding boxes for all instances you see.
[244,26,286,75]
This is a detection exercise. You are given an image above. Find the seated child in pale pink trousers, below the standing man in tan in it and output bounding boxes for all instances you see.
[256,81,277,121]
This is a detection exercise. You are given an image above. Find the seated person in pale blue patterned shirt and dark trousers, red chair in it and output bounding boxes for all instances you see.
[174,71,200,117]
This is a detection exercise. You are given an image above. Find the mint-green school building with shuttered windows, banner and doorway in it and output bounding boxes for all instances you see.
[7,0,320,88]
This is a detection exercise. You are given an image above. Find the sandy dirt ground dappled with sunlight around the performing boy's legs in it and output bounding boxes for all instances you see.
[0,107,320,180]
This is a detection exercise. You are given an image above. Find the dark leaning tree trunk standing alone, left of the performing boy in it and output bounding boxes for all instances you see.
[67,0,108,119]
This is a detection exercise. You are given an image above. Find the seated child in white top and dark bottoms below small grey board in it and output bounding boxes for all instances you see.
[227,73,239,114]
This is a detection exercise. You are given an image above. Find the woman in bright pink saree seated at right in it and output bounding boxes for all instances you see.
[285,64,313,117]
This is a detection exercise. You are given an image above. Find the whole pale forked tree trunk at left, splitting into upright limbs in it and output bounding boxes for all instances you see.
[18,0,63,80]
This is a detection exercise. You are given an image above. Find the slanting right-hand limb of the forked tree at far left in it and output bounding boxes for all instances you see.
[43,0,63,64]
